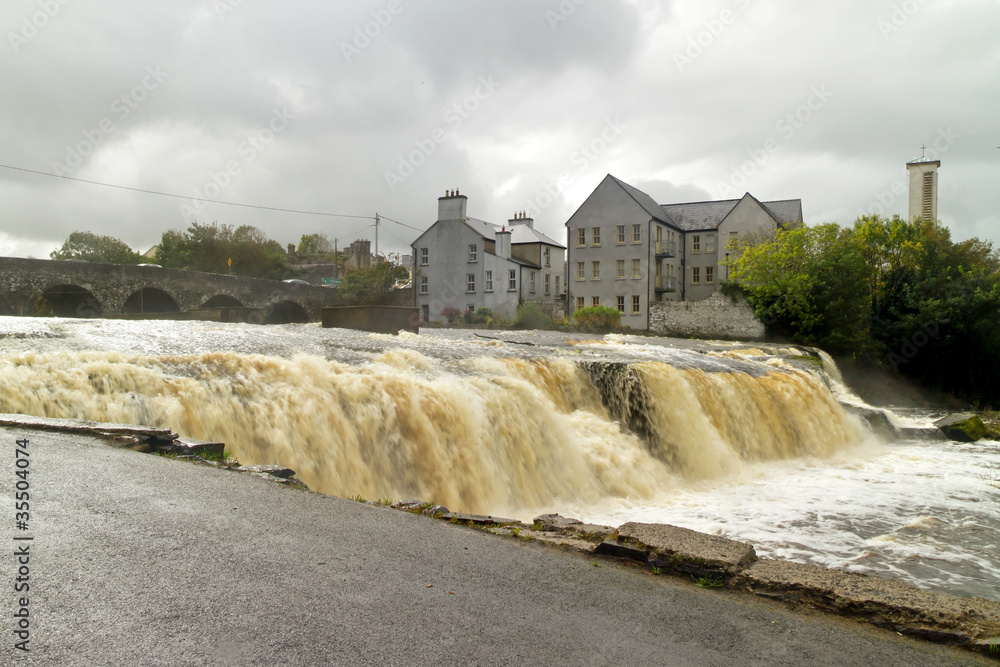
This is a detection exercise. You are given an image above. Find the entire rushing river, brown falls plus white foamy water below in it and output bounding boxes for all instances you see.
[0,318,1000,599]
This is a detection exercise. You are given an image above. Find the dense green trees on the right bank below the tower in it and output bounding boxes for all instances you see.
[723,216,1000,406]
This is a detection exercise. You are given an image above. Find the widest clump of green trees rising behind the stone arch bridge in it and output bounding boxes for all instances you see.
[157,222,287,280]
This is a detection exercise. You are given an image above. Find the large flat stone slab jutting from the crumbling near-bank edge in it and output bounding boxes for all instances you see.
[618,522,757,577]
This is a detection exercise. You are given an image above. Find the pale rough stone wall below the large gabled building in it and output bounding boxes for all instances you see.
[649,292,765,340]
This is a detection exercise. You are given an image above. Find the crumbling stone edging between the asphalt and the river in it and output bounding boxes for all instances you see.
[0,415,1000,657]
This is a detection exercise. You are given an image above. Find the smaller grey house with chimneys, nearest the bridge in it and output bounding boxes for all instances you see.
[412,191,566,322]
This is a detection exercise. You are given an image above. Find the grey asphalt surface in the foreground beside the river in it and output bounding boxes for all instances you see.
[0,429,996,667]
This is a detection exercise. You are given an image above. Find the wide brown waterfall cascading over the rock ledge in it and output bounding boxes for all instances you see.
[0,349,864,514]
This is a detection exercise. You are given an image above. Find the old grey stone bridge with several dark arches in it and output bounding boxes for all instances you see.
[0,257,342,324]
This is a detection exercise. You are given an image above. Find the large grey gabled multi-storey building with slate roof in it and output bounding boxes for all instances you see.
[566,174,802,330]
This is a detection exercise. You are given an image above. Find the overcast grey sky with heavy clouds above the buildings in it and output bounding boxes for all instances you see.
[0,0,1000,257]
